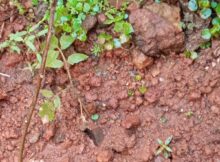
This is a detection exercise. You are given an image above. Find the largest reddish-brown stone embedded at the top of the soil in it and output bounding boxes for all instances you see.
[129,3,184,57]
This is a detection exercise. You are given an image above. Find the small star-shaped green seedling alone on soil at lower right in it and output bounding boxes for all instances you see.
[156,136,173,159]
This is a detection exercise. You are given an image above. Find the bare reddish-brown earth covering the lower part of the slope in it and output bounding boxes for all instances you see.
[0,0,220,162]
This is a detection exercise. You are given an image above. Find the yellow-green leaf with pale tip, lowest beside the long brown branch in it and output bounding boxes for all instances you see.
[39,101,55,123]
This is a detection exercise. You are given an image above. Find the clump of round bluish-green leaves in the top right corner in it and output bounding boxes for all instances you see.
[188,0,220,41]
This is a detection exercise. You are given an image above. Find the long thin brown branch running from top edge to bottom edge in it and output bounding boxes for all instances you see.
[19,0,57,162]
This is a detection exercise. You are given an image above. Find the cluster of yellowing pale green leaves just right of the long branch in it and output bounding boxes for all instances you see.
[39,89,61,123]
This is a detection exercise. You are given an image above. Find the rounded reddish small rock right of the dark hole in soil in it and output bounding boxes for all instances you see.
[122,115,141,129]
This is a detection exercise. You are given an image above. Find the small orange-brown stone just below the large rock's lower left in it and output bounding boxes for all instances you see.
[132,49,153,69]
